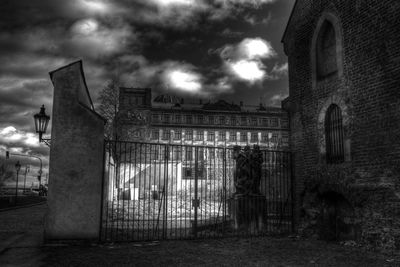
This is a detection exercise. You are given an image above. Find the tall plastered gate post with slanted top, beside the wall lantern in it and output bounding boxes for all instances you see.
[44,61,105,241]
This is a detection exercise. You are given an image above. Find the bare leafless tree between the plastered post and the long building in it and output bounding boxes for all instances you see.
[99,76,120,140]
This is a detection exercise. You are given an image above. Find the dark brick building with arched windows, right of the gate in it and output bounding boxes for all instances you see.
[282,0,400,248]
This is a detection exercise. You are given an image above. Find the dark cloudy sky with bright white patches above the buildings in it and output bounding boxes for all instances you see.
[0,0,295,183]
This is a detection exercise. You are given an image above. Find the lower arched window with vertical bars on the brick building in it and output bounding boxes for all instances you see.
[325,104,344,164]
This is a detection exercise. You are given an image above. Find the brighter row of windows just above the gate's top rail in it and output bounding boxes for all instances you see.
[151,129,289,144]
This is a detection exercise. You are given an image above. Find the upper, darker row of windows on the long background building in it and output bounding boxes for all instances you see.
[152,114,288,128]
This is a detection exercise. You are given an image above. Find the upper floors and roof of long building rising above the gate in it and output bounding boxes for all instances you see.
[118,88,289,150]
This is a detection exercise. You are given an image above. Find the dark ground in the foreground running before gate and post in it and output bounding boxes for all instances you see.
[0,204,400,266]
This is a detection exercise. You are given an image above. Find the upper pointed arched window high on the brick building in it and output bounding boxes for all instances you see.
[316,20,338,80]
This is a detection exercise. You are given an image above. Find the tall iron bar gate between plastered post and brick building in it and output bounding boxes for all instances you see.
[101,141,293,241]
